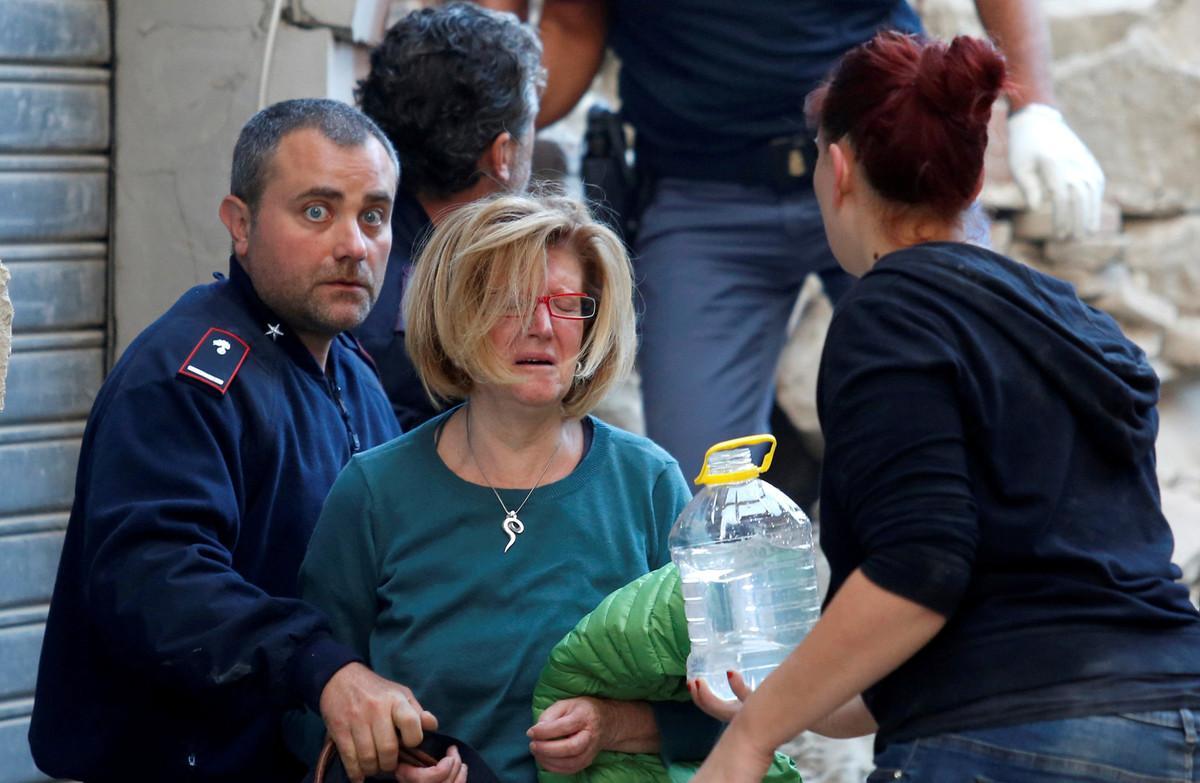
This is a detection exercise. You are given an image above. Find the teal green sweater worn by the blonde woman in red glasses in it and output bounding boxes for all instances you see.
[300,414,690,783]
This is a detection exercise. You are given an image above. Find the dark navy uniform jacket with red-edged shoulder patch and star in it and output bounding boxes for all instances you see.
[30,261,398,782]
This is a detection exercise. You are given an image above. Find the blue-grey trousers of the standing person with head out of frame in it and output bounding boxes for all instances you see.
[634,178,851,479]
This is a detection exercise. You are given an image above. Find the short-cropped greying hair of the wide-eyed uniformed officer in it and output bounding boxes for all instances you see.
[229,98,400,213]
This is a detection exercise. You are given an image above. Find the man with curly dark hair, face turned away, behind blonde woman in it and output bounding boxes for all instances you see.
[355,2,545,431]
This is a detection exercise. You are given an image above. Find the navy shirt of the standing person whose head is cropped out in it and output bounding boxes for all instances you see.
[610,0,920,159]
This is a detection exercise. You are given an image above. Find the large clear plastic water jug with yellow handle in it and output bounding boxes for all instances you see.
[668,435,821,699]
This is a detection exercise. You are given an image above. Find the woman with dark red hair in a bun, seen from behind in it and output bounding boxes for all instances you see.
[691,34,1200,783]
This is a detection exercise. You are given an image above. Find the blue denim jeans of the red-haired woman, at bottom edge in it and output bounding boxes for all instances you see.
[866,710,1200,783]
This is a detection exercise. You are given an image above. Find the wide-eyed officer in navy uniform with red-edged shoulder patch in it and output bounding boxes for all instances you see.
[30,100,433,783]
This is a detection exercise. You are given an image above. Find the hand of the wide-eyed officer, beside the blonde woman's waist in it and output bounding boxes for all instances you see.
[320,663,439,782]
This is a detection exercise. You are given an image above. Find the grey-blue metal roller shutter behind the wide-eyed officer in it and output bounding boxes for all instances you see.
[0,0,112,783]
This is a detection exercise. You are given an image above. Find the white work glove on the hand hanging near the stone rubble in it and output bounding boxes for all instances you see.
[1008,103,1104,239]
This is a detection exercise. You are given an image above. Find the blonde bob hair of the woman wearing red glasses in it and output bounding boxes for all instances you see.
[403,195,636,418]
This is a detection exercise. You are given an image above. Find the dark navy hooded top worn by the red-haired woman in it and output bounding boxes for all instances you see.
[817,243,1200,743]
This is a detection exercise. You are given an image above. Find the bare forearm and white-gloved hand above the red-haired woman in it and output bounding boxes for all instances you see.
[976,0,1104,239]
